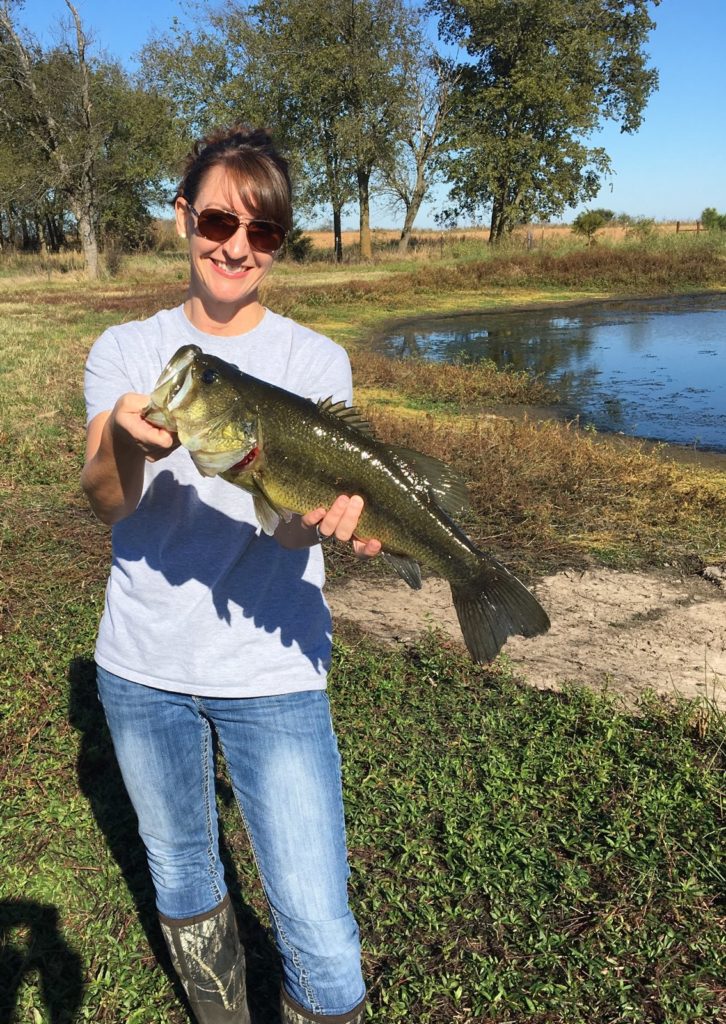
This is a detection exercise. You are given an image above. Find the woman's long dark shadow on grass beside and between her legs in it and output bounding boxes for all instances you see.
[68,658,281,1024]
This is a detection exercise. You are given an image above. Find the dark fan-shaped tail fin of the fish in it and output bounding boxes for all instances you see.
[452,558,550,663]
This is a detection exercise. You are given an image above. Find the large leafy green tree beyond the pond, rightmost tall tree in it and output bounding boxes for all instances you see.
[428,0,659,242]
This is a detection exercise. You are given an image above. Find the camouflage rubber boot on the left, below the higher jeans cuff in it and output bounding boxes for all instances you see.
[159,894,250,1024]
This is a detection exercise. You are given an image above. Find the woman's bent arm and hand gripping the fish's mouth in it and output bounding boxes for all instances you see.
[81,392,179,526]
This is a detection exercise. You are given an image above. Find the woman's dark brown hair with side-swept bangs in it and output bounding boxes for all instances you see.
[173,125,292,231]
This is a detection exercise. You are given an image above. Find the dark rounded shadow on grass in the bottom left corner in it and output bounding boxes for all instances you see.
[0,899,83,1024]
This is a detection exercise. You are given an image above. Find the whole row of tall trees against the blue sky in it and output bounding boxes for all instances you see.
[0,0,659,273]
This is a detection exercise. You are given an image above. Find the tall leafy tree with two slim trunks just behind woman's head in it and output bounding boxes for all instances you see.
[142,0,418,258]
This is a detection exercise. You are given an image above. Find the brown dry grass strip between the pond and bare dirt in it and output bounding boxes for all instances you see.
[356,401,726,573]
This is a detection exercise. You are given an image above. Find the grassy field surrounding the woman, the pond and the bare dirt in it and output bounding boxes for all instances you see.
[0,232,726,1024]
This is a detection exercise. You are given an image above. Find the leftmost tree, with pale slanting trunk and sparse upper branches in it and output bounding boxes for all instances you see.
[0,0,174,276]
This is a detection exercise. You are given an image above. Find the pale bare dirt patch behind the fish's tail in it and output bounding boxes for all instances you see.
[328,568,726,708]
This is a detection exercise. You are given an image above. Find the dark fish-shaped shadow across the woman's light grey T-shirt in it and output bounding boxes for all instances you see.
[114,470,331,672]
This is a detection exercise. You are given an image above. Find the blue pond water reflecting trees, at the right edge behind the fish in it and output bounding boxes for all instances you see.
[382,295,726,452]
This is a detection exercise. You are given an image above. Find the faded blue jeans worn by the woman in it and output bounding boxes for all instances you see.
[97,668,365,1015]
